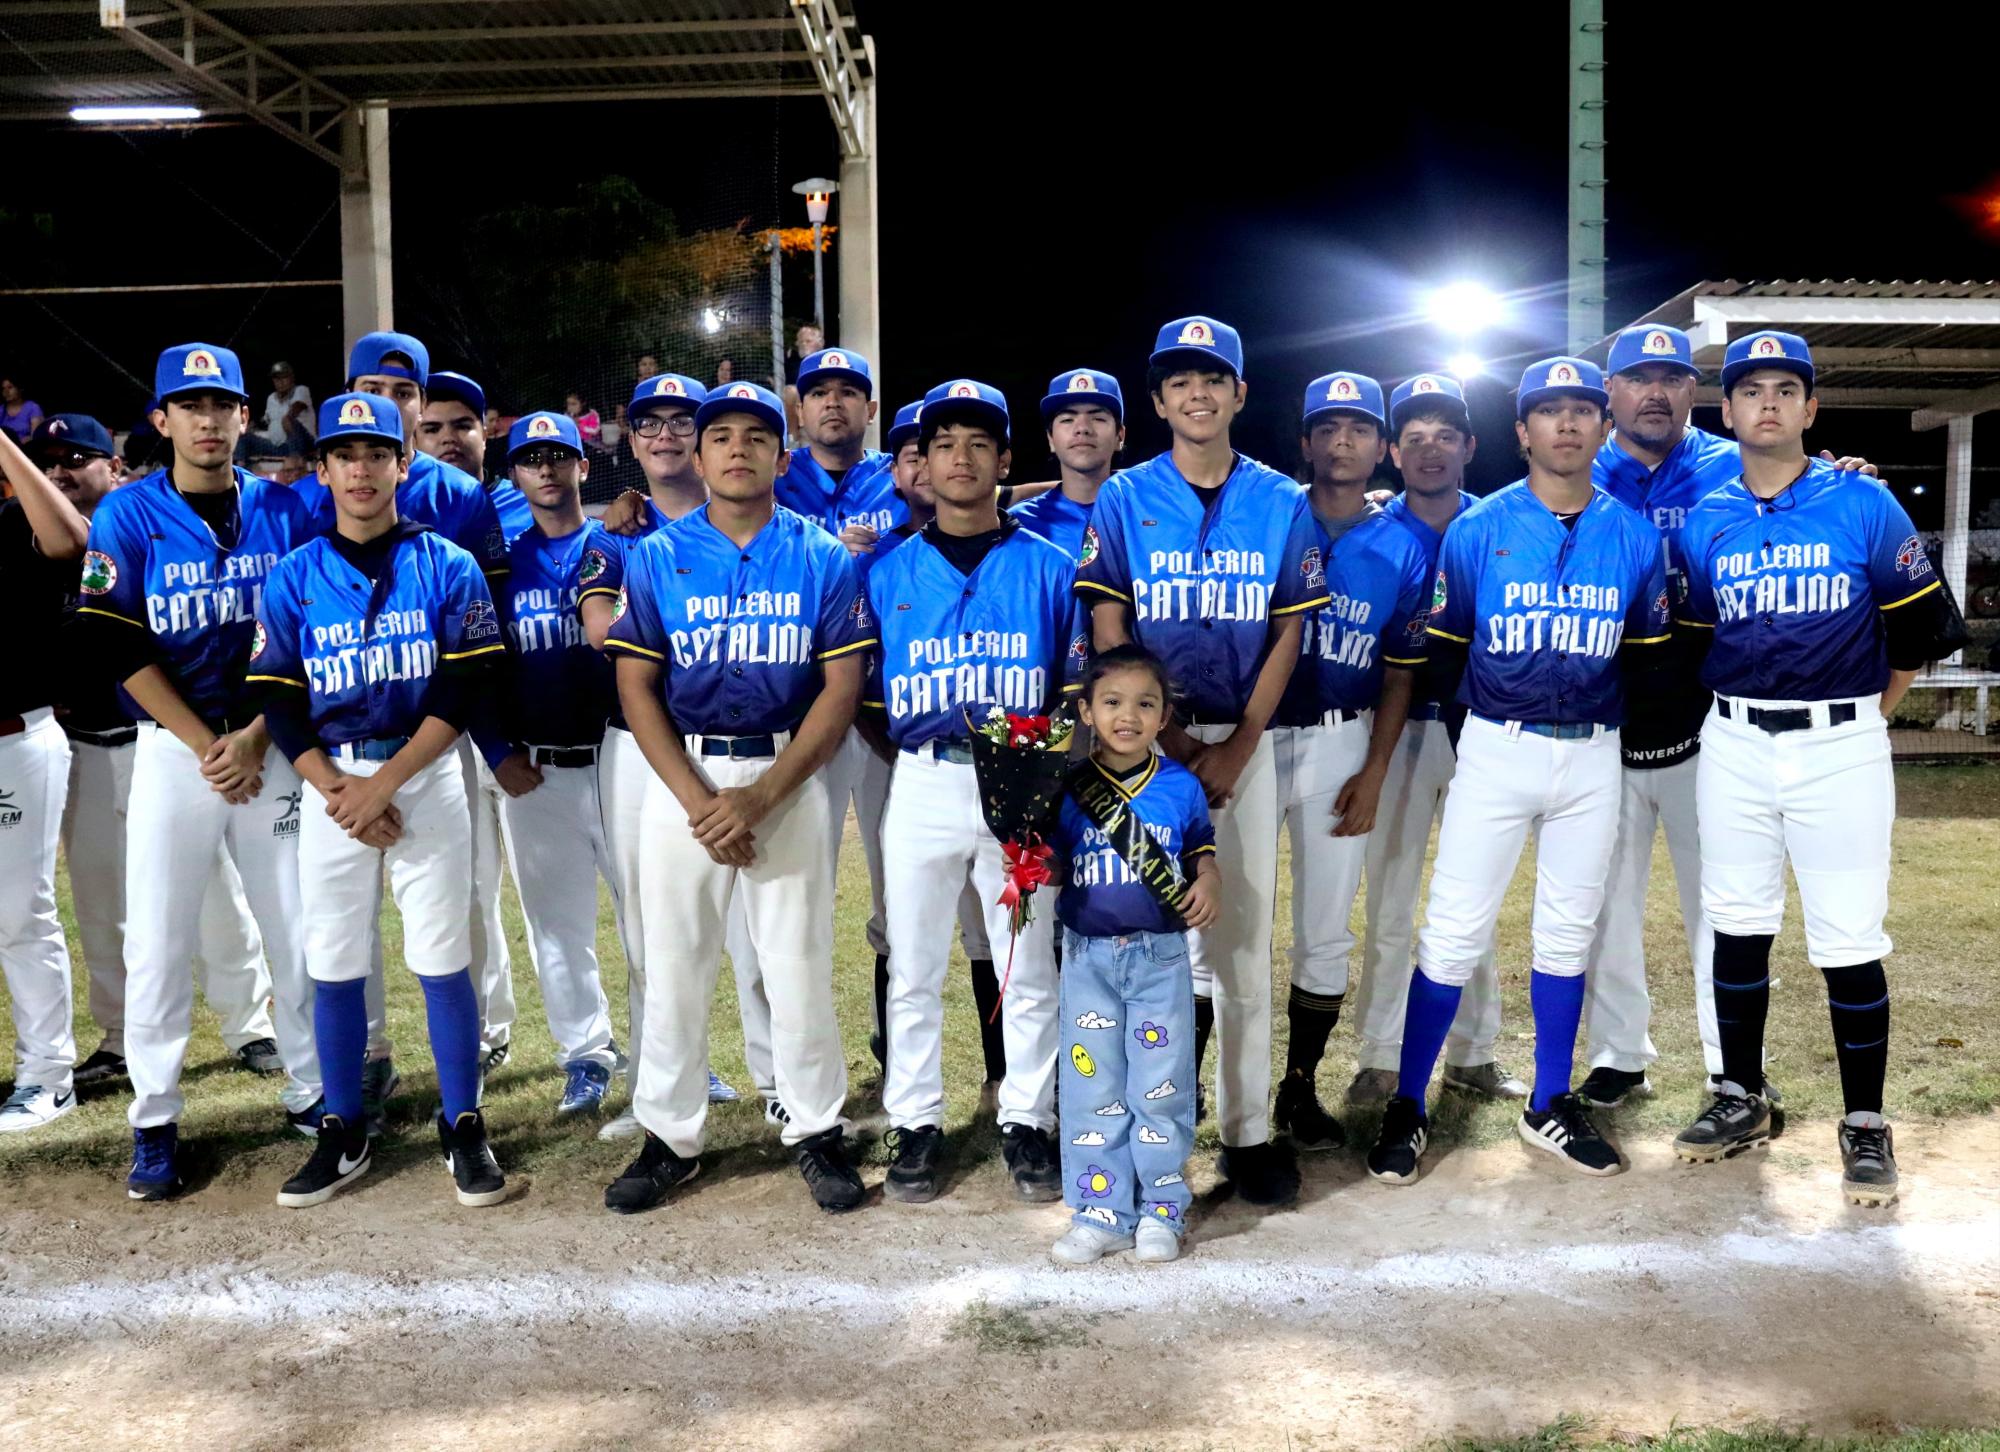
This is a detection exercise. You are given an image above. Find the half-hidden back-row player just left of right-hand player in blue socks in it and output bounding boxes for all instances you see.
[1348,374,1528,1104]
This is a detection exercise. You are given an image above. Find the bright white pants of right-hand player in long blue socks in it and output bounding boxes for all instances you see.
[1416,716,1624,984]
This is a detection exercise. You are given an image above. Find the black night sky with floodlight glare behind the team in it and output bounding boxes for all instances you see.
[0,0,2000,524]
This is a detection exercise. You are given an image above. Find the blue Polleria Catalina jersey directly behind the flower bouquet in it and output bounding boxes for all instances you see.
[866,520,1090,750]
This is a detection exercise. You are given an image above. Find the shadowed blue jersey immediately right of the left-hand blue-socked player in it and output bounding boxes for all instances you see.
[498,520,638,746]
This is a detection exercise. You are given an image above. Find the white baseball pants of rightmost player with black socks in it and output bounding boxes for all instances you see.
[1696,696,1896,968]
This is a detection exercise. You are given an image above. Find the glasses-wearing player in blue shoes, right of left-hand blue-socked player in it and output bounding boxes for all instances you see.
[480,412,622,1116]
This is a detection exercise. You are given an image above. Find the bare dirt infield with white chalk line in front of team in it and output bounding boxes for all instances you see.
[0,1116,2000,1450]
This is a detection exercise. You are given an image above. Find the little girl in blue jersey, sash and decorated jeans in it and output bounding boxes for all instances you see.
[1050,646,1216,1266]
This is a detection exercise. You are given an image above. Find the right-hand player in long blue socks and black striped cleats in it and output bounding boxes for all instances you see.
[1368,358,1670,1184]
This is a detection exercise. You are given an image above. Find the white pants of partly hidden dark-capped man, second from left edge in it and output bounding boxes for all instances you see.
[62,740,274,1056]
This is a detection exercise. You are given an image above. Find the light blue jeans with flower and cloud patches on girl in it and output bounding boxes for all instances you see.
[1060,930,1194,1236]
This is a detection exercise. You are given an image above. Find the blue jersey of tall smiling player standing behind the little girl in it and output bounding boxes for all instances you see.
[1076,454,1328,720]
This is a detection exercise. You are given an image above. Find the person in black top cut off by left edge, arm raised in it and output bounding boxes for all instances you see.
[0,416,90,1134]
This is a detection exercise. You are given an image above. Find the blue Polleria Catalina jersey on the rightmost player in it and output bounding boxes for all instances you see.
[1680,458,1938,700]
